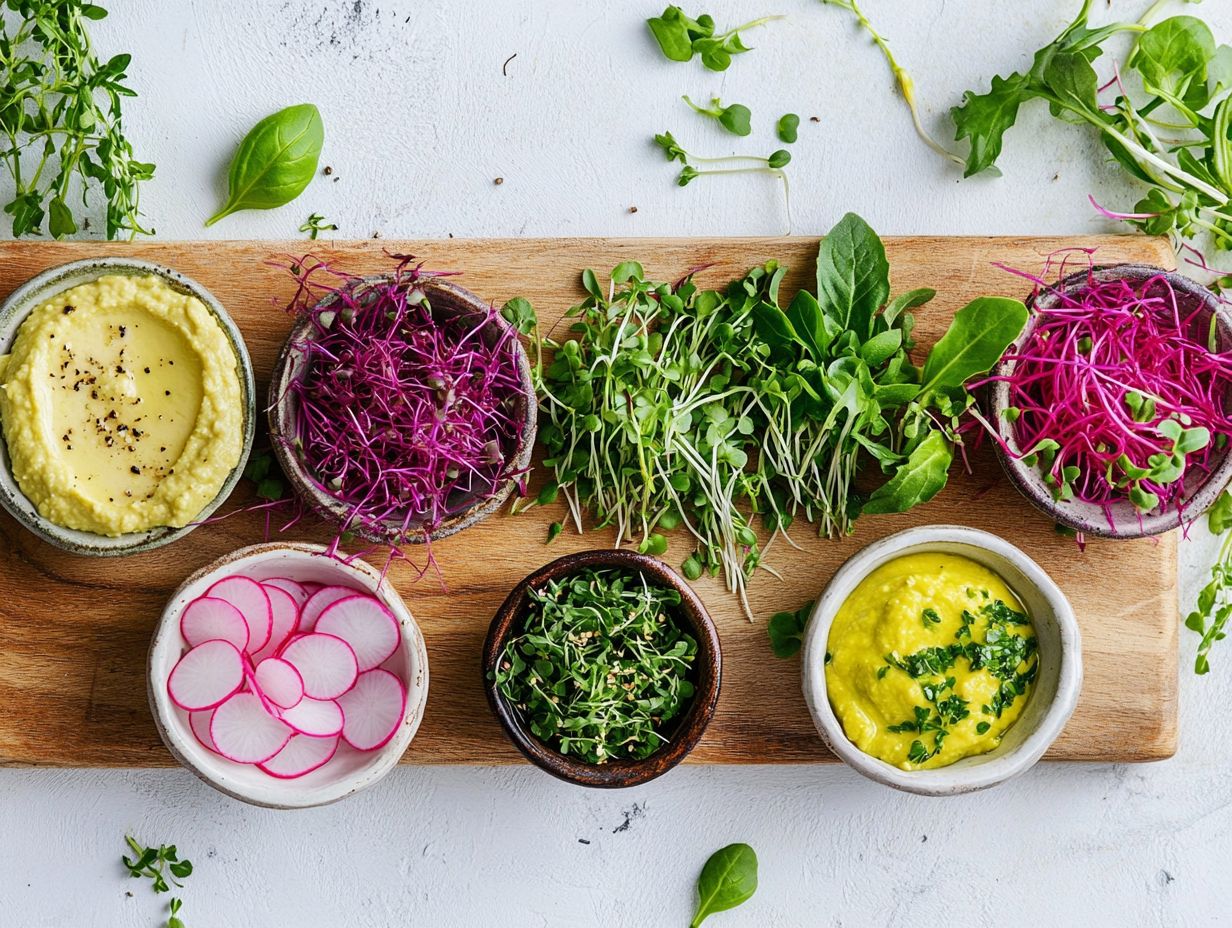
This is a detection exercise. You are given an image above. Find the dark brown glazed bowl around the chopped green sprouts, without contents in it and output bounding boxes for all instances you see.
[483,548,723,789]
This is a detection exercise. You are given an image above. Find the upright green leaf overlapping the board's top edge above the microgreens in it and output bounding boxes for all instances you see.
[817,213,890,341]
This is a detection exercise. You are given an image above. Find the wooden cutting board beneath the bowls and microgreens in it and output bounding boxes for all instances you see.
[0,235,1178,767]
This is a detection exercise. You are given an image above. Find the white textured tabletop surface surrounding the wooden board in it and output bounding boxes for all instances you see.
[0,0,1232,928]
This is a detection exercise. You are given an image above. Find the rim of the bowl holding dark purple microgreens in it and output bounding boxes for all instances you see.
[266,274,538,545]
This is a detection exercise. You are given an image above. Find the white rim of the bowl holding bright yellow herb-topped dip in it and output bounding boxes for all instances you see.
[801,525,1083,796]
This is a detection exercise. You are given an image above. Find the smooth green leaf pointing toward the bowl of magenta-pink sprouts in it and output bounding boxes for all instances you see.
[920,297,1027,394]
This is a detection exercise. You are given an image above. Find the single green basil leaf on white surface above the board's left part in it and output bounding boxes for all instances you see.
[206,104,325,226]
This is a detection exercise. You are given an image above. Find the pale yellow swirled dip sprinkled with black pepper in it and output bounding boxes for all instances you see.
[0,275,244,535]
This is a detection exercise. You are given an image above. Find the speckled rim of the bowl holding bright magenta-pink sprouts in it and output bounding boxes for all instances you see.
[983,261,1232,540]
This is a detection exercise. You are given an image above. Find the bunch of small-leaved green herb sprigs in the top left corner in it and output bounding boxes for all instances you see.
[0,0,154,239]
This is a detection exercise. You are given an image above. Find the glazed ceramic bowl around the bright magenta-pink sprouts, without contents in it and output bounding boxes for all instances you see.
[984,264,1232,539]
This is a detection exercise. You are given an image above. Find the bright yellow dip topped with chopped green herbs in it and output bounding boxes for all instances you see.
[825,553,1039,770]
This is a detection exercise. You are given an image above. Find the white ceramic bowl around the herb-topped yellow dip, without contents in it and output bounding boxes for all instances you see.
[803,525,1082,796]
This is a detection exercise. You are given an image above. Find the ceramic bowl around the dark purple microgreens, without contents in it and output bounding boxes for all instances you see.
[269,275,538,545]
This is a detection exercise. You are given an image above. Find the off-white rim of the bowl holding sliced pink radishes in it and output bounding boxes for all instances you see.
[145,541,429,810]
